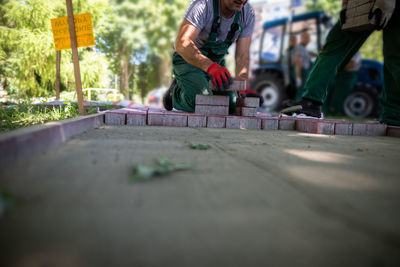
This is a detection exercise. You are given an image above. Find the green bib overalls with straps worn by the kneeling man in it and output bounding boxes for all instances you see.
[172,0,241,114]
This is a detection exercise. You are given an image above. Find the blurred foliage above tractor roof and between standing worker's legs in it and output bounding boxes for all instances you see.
[306,0,383,61]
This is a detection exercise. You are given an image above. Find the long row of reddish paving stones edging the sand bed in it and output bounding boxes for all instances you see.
[104,107,400,137]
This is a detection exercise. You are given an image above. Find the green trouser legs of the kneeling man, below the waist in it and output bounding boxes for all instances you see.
[172,53,237,114]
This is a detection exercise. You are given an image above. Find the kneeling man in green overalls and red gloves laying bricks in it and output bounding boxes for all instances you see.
[163,0,254,113]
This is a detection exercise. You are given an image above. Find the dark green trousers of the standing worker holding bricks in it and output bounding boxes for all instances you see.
[303,0,400,126]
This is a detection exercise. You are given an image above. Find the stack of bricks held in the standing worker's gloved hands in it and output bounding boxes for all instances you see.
[342,0,376,31]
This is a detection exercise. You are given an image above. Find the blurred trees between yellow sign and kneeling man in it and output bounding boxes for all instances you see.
[97,0,189,99]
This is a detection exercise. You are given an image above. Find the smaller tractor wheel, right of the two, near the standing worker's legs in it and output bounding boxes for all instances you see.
[344,87,380,119]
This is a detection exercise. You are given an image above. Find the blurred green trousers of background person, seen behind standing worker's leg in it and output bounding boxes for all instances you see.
[322,70,358,115]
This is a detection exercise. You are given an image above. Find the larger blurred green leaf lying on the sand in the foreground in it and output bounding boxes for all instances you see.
[131,157,191,182]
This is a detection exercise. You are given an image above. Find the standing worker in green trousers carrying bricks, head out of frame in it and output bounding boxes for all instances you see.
[282,0,400,126]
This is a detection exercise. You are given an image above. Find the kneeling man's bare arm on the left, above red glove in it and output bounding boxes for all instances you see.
[175,19,213,71]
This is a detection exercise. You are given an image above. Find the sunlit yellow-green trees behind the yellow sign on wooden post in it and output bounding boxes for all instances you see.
[0,0,109,97]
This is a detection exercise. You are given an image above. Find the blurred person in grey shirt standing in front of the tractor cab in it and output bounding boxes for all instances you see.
[294,32,315,100]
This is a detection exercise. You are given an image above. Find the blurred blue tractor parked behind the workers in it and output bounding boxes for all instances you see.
[250,12,383,118]
